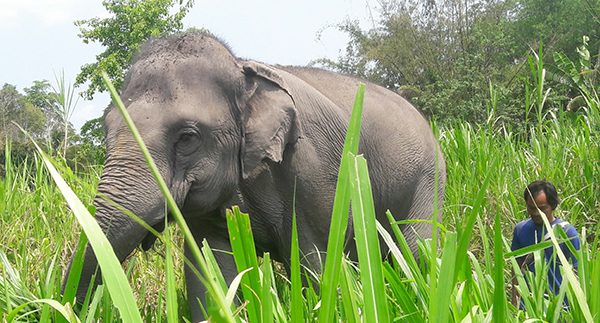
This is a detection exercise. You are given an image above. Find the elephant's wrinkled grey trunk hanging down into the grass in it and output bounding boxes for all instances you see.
[63,157,167,302]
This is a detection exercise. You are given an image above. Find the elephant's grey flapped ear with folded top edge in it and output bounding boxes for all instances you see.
[240,61,302,179]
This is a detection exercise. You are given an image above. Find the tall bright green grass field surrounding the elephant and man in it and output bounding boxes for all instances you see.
[0,52,600,322]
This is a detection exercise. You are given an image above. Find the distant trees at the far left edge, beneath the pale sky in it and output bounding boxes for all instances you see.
[0,78,105,172]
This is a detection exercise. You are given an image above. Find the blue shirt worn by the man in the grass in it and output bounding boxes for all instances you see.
[511,218,581,293]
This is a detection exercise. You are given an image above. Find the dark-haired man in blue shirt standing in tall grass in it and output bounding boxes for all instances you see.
[511,181,580,306]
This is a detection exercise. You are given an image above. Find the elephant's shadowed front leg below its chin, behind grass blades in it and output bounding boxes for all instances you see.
[185,219,237,322]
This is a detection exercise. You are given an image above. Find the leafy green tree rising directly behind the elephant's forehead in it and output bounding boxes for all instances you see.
[75,0,193,99]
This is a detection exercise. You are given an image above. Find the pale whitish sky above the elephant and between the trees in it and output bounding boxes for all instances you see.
[0,0,378,129]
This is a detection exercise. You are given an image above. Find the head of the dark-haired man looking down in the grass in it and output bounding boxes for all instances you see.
[523,181,558,225]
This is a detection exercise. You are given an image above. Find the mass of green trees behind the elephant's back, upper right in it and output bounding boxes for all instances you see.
[324,0,600,134]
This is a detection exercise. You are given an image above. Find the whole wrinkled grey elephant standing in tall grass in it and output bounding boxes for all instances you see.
[65,33,445,320]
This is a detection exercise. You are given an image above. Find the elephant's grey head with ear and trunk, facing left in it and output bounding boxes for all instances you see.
[66,33,301,300]
